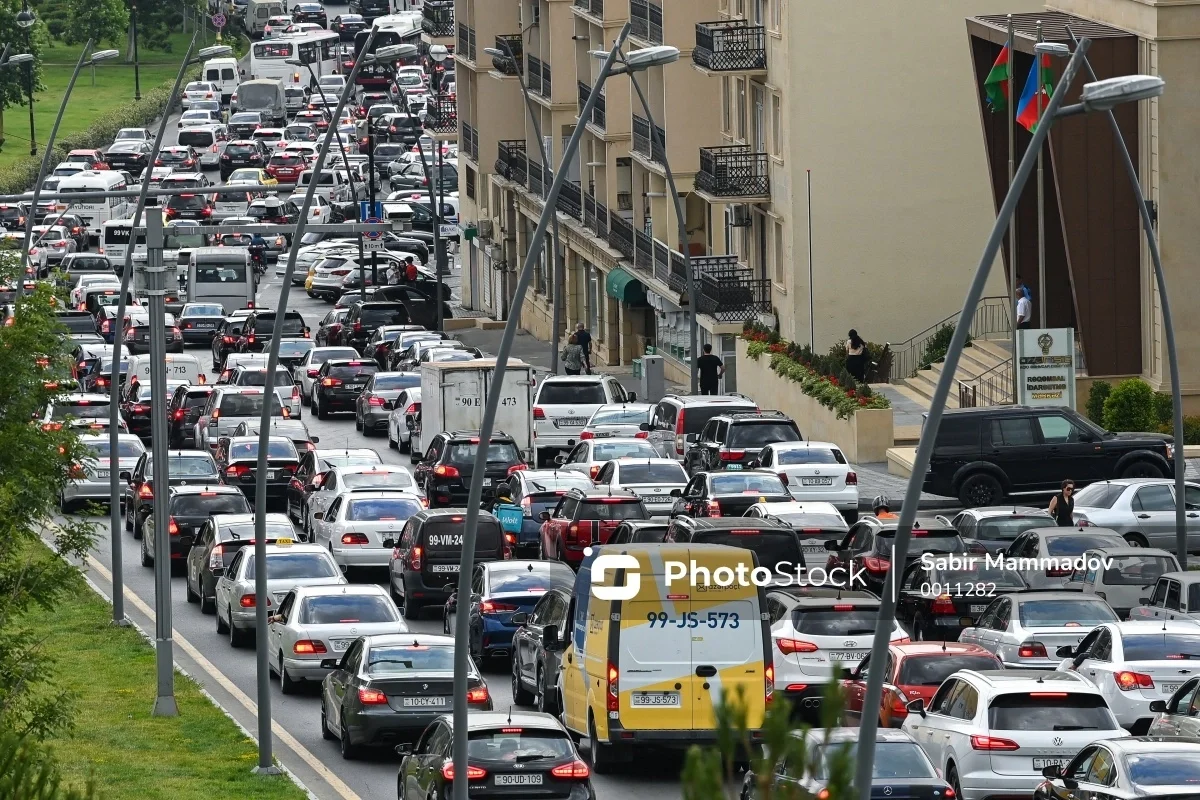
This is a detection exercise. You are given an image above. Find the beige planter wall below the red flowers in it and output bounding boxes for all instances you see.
[737,337,895,464]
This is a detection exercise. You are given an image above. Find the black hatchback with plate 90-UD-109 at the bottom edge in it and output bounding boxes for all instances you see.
[396,711,595,800]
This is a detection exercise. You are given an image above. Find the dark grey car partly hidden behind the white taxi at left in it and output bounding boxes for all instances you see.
[184,510,295,614]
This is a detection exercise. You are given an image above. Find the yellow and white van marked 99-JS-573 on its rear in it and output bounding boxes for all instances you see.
[547,543,774,772]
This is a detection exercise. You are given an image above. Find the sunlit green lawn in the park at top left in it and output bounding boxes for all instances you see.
[0,34,212,169]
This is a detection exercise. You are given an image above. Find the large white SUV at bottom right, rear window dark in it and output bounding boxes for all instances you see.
[901,669,1126,800]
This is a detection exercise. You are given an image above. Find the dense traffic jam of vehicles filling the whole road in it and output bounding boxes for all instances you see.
[23,0,1200,800]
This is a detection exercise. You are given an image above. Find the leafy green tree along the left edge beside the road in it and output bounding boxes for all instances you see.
[0,249,95,743]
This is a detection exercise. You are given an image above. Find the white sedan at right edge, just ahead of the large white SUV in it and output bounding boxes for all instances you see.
[1056,620,1200,735]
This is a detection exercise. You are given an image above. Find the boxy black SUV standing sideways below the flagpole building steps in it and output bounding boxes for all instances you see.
[924,405,1175,506]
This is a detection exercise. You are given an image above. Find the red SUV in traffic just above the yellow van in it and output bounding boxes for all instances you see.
[541,488,650,567]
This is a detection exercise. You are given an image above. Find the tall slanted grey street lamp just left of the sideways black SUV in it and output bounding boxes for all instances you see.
[854,38,1171,800]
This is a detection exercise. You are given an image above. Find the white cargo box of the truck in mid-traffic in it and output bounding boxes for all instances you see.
[413,359,538,462]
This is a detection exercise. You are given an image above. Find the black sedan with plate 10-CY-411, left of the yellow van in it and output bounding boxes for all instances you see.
[320,633,494,762]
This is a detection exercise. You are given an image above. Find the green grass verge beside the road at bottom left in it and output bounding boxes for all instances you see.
[30,546,306,800]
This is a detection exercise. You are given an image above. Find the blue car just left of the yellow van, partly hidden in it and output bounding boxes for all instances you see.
[451,560,575,664]
